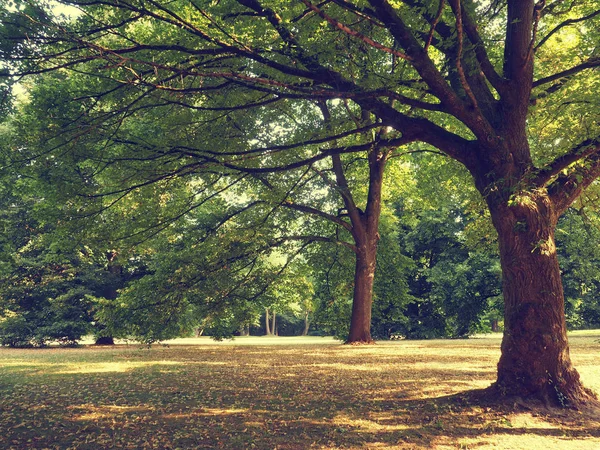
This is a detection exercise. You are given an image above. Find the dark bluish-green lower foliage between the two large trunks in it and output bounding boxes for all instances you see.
[401,204,501,338]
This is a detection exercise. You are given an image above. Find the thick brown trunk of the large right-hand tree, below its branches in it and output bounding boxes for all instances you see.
[492,192,592,407]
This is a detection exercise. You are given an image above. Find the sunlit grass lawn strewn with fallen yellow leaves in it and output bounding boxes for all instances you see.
[0,331,600,450]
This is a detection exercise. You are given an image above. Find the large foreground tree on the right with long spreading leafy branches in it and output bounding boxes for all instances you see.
[2,0,600,406]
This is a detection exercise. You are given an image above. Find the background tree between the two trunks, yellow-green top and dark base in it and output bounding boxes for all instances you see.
[395,153,502,338]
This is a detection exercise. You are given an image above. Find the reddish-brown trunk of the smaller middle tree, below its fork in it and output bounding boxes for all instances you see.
[346,246,377,344]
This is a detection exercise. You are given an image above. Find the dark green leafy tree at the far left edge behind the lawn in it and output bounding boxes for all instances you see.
[0,177,135,347]
